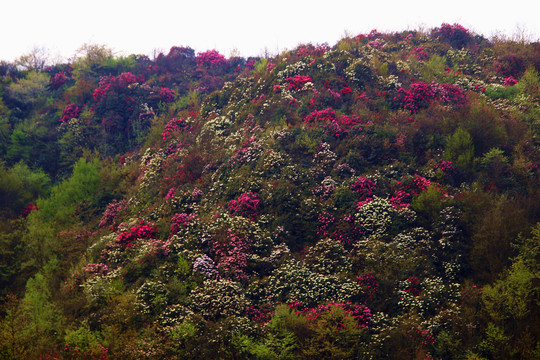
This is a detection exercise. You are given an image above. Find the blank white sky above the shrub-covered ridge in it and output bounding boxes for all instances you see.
[0,0,540,61]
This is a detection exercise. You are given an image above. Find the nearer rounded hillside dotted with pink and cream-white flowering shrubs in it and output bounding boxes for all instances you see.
[3,24,540,359]
